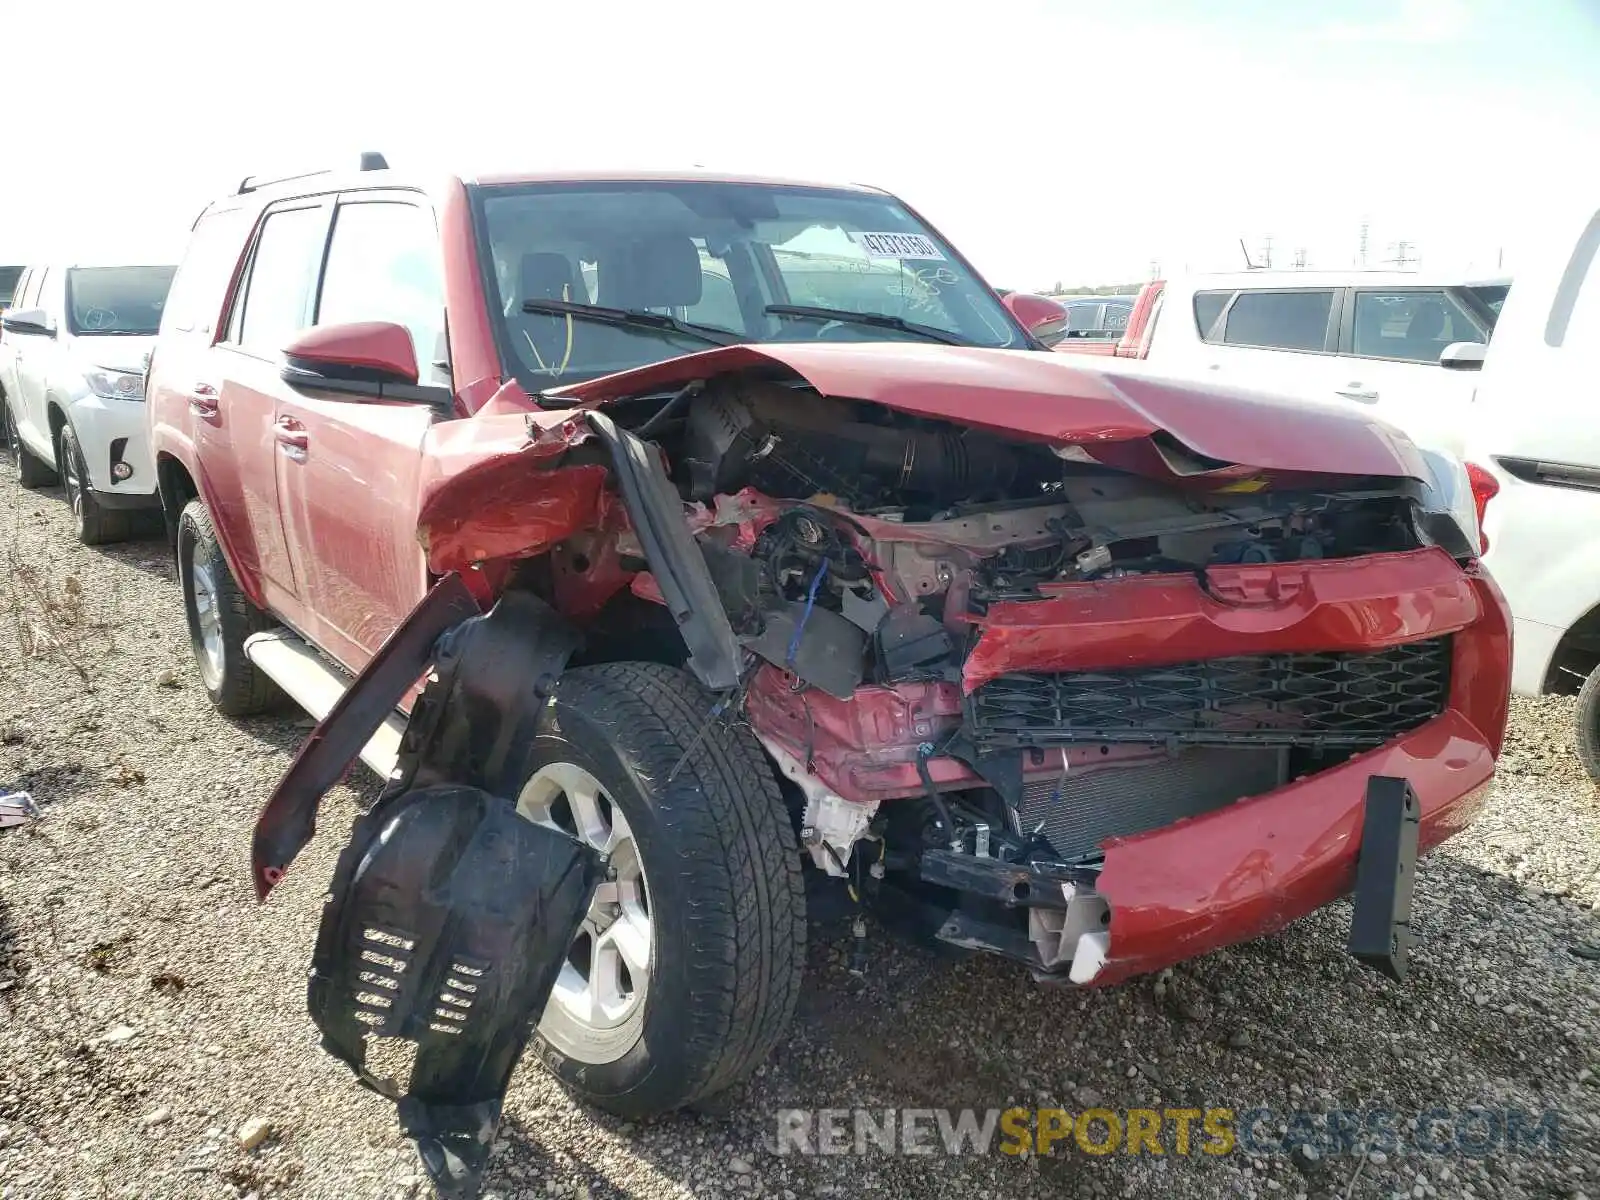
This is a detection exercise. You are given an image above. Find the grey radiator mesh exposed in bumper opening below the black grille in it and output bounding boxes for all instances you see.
[1021,747,1288,862]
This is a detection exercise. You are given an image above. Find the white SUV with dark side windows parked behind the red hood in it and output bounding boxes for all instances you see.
[1058,270,1510,454]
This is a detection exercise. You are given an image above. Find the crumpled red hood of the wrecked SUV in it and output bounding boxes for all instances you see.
[550,342,1430,482]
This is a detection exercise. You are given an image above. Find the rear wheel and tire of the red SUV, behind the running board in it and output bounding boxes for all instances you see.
[178,499,283,717]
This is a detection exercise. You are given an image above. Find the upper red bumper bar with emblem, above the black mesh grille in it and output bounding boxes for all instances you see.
[962,549,1483,693]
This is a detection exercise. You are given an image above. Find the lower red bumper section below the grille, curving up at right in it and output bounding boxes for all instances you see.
[1094,574,1510,986]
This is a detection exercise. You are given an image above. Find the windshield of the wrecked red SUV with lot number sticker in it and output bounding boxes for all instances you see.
[475,181,1030,389]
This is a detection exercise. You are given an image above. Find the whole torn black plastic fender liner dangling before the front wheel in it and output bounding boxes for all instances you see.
[307,595,603,1197]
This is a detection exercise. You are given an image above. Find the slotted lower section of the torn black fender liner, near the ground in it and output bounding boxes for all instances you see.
[307,784,605,1197]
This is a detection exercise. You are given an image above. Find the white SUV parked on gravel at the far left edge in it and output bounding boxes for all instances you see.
[0,266,176,546]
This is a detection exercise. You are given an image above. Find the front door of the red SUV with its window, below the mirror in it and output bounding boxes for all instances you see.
[274,192,450,670]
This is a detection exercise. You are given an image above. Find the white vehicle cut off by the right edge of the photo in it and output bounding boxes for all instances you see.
[1466,198,1600,781]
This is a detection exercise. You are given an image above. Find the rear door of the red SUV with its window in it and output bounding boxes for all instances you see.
[203,198,333,629]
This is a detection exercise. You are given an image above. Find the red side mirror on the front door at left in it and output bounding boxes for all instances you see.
[278,322,454,408]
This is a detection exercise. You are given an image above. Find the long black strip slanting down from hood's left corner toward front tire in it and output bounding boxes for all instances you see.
[586,411,742,691]
